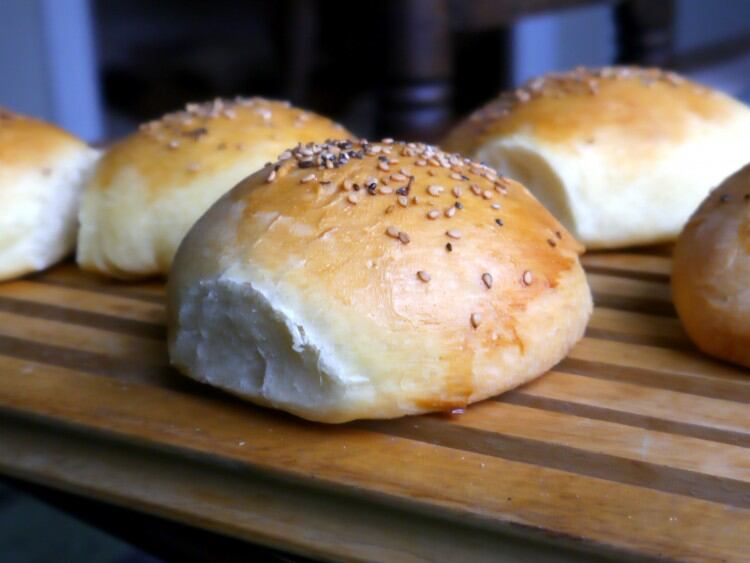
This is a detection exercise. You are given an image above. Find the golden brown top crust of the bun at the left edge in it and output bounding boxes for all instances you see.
[0,107,86,170]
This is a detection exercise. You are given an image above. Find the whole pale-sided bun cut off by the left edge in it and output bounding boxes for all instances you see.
[0,108,98,280]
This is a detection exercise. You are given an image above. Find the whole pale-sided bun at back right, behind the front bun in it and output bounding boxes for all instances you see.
[444,67,750,248]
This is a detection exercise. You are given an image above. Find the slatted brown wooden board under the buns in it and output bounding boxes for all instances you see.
[0,251,750,561]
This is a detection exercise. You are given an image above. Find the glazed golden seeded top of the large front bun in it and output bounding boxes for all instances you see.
[178,140,583,316]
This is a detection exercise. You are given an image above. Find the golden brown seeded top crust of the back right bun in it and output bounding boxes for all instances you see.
[443,67,730,158]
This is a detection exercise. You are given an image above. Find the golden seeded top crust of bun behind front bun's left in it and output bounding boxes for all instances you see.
[93,98,350,194]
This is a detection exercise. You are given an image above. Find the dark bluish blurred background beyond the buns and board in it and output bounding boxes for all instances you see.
[0,0,750,563]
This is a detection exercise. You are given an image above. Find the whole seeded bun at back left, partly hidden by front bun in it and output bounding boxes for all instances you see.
[77,98,349,279]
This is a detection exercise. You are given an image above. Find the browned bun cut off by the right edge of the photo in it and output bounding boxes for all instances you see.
[672,164,750,368]
